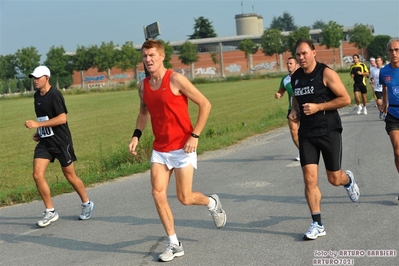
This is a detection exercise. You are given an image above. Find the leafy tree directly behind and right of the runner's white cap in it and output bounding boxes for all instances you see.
[44,46,73,89]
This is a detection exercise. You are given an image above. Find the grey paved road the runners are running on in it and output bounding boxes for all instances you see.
[0,103,399,266]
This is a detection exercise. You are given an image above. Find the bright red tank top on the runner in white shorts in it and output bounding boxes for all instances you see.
[143,70,193,152]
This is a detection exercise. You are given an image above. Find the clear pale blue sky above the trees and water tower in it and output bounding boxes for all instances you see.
[0,0,399,63]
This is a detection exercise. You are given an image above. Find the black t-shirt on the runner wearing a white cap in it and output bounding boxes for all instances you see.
[34,87,72,147]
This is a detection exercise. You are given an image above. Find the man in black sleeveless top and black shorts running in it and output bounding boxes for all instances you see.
[289,40,360,240]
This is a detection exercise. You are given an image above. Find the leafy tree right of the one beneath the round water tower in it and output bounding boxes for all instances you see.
[260,29,287,64]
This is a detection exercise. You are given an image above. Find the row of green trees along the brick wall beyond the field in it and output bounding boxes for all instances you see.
[0,12,391,93]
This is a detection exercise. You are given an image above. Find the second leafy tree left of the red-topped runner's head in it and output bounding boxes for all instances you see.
[94,41,117,85]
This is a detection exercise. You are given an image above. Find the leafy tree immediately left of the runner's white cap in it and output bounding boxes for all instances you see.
[15,46,41,90]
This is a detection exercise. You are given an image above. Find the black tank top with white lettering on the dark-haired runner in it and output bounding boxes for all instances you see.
[291,62,342,137]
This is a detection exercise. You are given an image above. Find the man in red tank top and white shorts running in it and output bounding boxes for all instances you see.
[129,40,226,261]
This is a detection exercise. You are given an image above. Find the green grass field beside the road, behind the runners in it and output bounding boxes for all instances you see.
[0,73,364,206]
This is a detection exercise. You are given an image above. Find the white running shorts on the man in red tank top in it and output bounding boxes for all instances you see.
[151,149,197,170]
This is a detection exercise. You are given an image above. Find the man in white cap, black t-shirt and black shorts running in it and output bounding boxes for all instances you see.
[25,66,94,227]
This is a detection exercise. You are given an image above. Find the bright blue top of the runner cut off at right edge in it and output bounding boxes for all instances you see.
[379,64,399,119]
